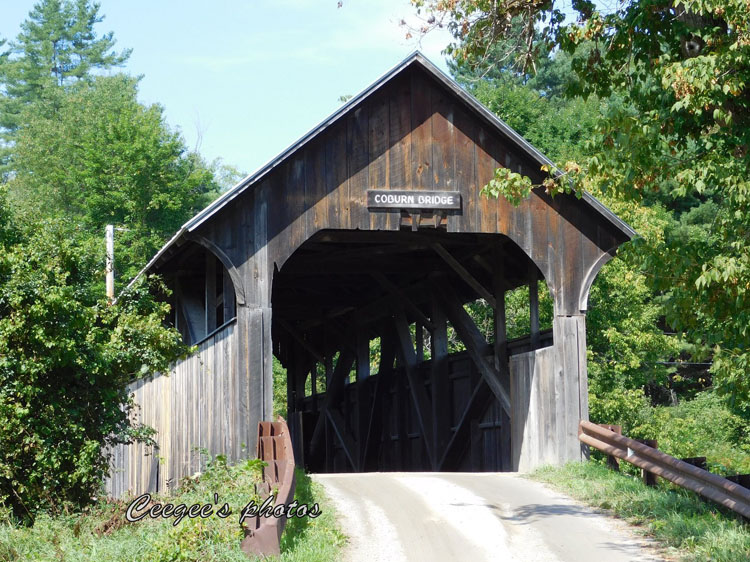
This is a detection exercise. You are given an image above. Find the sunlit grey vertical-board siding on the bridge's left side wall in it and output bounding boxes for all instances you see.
[105,322,239,498]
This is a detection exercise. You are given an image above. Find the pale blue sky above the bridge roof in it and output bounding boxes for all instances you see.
[0,0,450,173]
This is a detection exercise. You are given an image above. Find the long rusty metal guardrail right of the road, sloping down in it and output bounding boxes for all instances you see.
[578,420,750,519]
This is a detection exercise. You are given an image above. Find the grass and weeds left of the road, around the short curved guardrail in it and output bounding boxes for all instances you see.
[0,461,344,562]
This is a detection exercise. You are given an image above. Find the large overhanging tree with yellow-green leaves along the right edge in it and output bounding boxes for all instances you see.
[418,0,750,405]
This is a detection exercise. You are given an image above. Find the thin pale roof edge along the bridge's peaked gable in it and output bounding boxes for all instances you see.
[131,51,636,284]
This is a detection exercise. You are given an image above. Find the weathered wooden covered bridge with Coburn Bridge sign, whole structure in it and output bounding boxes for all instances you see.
[108,53,634,496]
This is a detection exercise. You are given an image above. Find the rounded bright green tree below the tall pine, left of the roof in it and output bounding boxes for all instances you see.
[8,75,219,279]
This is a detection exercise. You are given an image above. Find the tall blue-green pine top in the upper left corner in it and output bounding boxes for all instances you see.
[0,0,131,131]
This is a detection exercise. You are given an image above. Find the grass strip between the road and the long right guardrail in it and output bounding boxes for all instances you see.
[530,462,750,562]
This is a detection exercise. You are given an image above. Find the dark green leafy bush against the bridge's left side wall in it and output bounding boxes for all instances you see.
[0,207,187,520]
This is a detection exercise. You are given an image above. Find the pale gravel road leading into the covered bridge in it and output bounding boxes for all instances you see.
[313,472,663,562]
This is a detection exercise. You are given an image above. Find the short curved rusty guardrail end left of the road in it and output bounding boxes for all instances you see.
[240,416,295,556]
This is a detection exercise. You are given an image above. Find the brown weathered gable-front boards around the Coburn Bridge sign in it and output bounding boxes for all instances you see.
[195,67,624,314]
